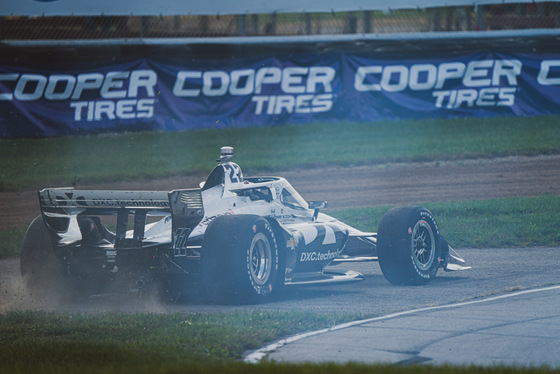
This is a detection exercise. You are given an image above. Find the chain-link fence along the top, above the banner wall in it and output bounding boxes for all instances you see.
[0,2,560,40]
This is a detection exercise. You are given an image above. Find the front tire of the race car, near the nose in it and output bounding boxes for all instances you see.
[377,207,442,285]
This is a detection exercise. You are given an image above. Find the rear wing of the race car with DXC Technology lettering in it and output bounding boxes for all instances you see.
[39,188,204,251]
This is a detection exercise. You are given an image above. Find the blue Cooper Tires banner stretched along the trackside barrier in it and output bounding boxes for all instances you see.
[0,52,560,138]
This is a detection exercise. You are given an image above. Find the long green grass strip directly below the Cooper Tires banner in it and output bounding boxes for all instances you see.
[0,116,560,191]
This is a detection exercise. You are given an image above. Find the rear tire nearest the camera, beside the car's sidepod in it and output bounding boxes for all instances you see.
[201,215,279,304]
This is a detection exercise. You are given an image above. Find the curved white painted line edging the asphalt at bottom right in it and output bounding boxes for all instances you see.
[243,285,560,364]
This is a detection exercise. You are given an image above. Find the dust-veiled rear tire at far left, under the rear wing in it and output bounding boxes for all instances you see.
[20,216,69,301]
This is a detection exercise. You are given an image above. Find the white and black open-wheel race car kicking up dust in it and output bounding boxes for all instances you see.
[21,147,468,303]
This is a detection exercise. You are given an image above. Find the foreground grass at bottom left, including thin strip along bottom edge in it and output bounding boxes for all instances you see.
[0,310,554,374]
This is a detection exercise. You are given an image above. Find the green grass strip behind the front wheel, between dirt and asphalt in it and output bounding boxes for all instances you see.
[0,196,560,259]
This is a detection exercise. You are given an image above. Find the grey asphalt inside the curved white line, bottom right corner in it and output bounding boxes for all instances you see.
[252,286,560,367]
